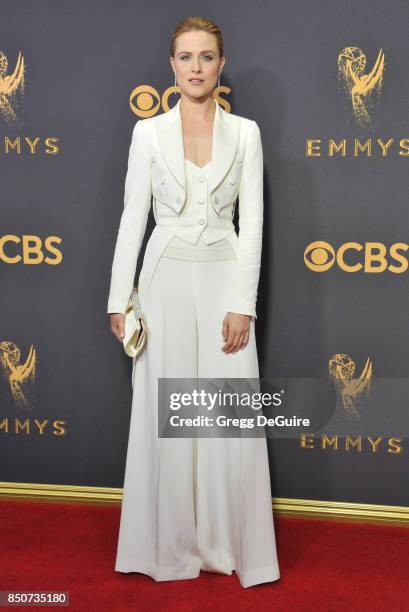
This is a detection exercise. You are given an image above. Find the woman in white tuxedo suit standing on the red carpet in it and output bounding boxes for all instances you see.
[107,17,280,587]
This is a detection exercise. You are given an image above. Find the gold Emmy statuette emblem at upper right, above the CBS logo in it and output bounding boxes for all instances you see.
[338,47,385,127]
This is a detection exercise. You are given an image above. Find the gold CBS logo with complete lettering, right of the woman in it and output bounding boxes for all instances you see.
[304,240,409,274]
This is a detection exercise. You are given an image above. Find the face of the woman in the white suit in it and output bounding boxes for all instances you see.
[170,31,225,98]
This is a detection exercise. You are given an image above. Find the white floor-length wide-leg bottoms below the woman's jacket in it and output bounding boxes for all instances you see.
[115,226,280,587]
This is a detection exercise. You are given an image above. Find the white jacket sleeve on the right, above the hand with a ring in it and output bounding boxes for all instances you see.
[227,121,264,318]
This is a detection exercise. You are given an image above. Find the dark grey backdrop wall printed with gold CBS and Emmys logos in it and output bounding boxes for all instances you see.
[0,0,409,506]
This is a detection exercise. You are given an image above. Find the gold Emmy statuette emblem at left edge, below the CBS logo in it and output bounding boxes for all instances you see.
[0,340,36,408]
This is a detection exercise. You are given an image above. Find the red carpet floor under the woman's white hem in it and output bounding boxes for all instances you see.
[0,501,409,612]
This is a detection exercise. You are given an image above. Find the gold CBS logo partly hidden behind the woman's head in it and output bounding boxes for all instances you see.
[129,84,231,119]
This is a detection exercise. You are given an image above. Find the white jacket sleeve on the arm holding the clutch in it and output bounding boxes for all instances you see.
[107,120,152,314]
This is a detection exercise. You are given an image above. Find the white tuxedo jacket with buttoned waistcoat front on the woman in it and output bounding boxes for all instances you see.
[107,99,263,317]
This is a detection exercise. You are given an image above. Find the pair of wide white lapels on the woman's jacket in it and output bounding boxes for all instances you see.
[156,98,240,196]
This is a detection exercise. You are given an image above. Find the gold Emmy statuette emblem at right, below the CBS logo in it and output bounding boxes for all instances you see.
[328,353,373,419]
